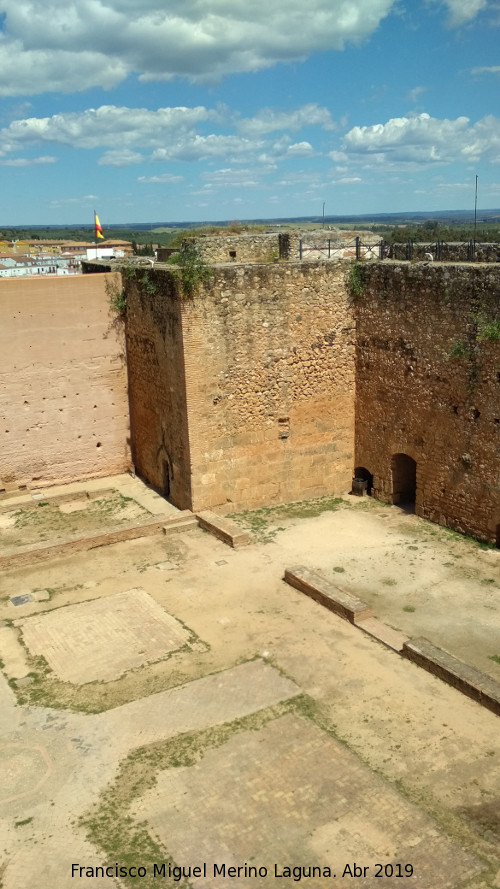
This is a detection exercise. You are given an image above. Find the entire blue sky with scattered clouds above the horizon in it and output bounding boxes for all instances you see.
[0,0,500,229]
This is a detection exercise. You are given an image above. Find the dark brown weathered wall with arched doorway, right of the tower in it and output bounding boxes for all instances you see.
[355,263,500,542]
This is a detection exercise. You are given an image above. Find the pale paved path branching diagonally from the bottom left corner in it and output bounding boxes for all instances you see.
[0,661,299,889]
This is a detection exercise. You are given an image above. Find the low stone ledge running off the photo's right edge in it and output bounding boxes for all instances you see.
[401,636,500,716]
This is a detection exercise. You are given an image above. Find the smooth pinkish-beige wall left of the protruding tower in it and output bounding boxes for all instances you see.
[0,275,130,489]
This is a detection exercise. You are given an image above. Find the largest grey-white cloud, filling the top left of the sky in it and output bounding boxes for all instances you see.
[0,0,400,96]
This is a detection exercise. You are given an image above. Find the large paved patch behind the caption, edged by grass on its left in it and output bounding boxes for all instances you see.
[133,714,482,889]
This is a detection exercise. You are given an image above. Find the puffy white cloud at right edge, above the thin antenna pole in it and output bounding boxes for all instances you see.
[342,114,500,167]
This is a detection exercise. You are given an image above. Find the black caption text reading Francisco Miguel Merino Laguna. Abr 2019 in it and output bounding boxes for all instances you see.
[71,862,413,883]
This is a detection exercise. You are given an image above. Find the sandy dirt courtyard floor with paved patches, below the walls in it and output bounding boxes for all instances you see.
[0,479,500,889]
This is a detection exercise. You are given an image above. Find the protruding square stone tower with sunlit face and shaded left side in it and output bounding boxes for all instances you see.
[127,263,354,511]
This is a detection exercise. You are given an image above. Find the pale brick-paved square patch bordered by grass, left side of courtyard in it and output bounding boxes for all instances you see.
[20,588,189,684]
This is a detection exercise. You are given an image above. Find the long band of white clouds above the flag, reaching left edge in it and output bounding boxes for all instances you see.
[0,104,331,167]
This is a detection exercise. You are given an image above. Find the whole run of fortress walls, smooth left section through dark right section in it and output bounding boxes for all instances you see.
[0,253,500,543]
